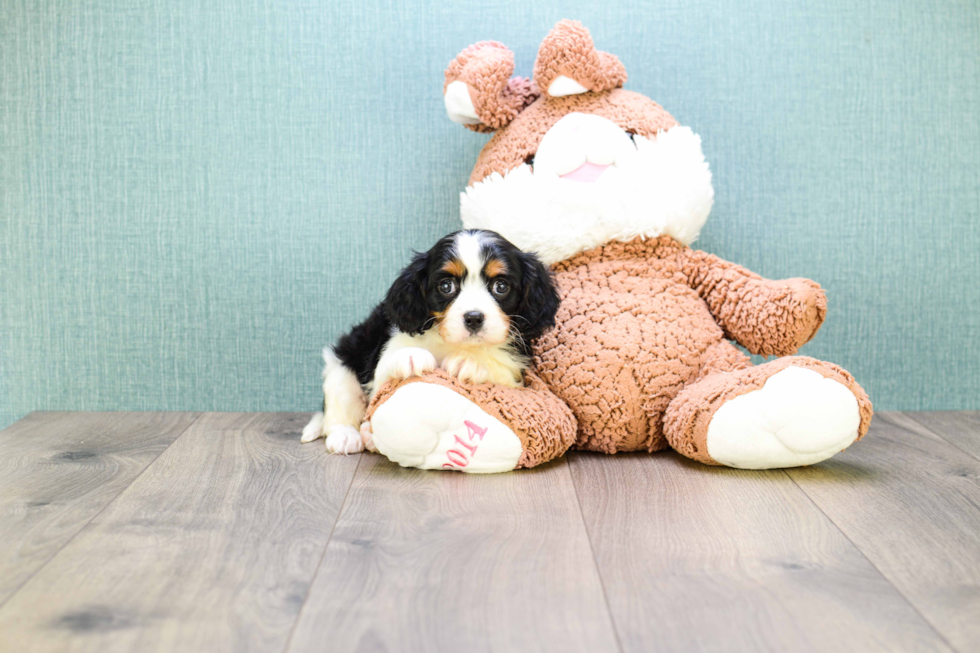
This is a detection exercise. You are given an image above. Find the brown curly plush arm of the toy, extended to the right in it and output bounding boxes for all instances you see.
[681,250,827,356]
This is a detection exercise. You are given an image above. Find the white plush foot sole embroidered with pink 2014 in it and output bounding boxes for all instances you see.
[371,383,523,474]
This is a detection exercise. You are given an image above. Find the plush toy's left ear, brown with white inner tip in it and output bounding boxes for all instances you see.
[442,41,540,132]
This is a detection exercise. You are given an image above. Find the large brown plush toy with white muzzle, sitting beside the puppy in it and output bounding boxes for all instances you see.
[368,21,872,472]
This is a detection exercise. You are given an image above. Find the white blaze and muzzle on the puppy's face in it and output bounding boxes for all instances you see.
[444,232,509,344]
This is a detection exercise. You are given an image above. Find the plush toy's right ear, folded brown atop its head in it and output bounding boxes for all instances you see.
[534,20,626,97]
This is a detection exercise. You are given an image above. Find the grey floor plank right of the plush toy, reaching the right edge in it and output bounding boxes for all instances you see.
[789,413,980,653]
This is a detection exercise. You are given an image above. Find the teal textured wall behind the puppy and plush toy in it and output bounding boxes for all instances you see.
[0,0,980,426]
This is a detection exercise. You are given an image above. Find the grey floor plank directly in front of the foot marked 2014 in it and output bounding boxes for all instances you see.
[288,456,617,653]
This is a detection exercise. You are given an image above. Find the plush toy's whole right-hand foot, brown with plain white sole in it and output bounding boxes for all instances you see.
[665,357,871,469]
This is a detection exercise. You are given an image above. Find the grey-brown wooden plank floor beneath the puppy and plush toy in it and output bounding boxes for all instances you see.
[0,413,980,653]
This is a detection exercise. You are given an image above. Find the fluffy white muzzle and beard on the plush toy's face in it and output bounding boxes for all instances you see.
[460,119,714,264]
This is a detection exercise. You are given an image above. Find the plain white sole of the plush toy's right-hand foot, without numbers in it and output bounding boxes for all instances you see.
[707,367,861,469]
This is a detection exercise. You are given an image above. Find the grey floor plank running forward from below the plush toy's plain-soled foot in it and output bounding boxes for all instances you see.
[570,452,948,652]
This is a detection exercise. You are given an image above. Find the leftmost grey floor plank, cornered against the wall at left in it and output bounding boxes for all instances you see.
[0,413,197,605]
